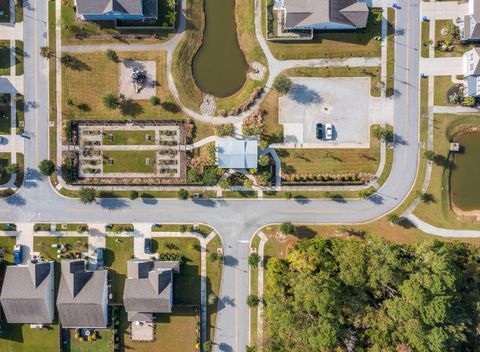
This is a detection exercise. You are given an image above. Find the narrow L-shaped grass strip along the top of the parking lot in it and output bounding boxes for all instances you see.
[283,66,382,97]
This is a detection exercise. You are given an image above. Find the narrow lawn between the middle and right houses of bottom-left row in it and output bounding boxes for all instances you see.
[105,236,133,304]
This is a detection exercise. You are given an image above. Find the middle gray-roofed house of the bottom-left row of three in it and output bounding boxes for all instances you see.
[57,259,108,328]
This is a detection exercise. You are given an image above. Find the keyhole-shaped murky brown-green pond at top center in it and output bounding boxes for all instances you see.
[193,0,248,98]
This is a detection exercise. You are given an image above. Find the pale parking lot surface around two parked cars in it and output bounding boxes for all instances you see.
[279,77,371,148]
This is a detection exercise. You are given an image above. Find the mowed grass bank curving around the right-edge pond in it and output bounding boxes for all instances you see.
[415,114,480,230]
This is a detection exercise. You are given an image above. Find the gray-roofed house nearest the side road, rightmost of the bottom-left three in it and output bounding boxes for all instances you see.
[123,259,180,323]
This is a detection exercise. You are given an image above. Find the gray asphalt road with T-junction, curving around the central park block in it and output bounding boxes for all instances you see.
[8,0,420,352]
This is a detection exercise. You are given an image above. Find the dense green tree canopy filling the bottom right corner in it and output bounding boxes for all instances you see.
[264,237,480,352]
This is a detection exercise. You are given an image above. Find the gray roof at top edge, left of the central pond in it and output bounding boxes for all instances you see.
[76,0,143,15]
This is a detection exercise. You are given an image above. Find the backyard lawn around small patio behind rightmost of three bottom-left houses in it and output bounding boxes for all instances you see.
[122,307,197,352]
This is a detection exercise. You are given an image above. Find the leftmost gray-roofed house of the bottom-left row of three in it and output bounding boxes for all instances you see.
[0,262,55,324]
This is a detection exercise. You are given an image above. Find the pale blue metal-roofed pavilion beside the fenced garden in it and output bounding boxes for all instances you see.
[217,138,258,169]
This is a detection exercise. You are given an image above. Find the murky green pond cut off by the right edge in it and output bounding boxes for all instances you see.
[450,132,480,211]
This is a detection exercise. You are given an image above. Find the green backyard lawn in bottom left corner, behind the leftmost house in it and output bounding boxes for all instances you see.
[0,324,60,352]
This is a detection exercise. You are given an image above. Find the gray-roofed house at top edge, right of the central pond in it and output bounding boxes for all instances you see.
[283,0,369,30]
